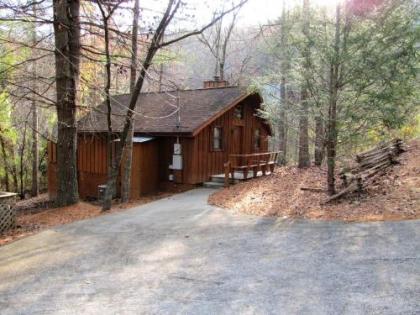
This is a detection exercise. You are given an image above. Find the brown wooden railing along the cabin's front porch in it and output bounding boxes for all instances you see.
[224,151,281,186]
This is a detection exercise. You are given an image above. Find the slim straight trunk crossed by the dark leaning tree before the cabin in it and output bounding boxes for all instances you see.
[121,0,140,202]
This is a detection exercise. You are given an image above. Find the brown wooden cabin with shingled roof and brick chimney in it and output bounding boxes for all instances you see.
[48,81,271,198]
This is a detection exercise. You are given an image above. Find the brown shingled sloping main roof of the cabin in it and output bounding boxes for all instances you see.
[78,87,261,134]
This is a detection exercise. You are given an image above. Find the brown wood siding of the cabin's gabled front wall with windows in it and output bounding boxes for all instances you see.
[182,98,268,184]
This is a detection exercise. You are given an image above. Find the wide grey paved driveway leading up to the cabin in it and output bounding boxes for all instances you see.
[0,189,420,315]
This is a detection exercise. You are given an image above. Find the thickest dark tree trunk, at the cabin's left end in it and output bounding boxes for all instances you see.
[53,0,80,207]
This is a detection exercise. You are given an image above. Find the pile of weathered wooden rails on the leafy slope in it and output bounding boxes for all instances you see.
[325,139,405,203]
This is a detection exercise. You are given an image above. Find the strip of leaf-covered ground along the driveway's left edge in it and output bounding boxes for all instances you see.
[0,183,193,246]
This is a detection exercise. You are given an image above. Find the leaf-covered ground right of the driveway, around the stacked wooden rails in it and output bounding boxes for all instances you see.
[209,140,420,221]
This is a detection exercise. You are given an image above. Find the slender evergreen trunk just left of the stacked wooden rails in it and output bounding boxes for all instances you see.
[327,4,341,195]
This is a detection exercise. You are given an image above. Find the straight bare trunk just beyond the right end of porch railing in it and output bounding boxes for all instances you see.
[298,0,310,168]
